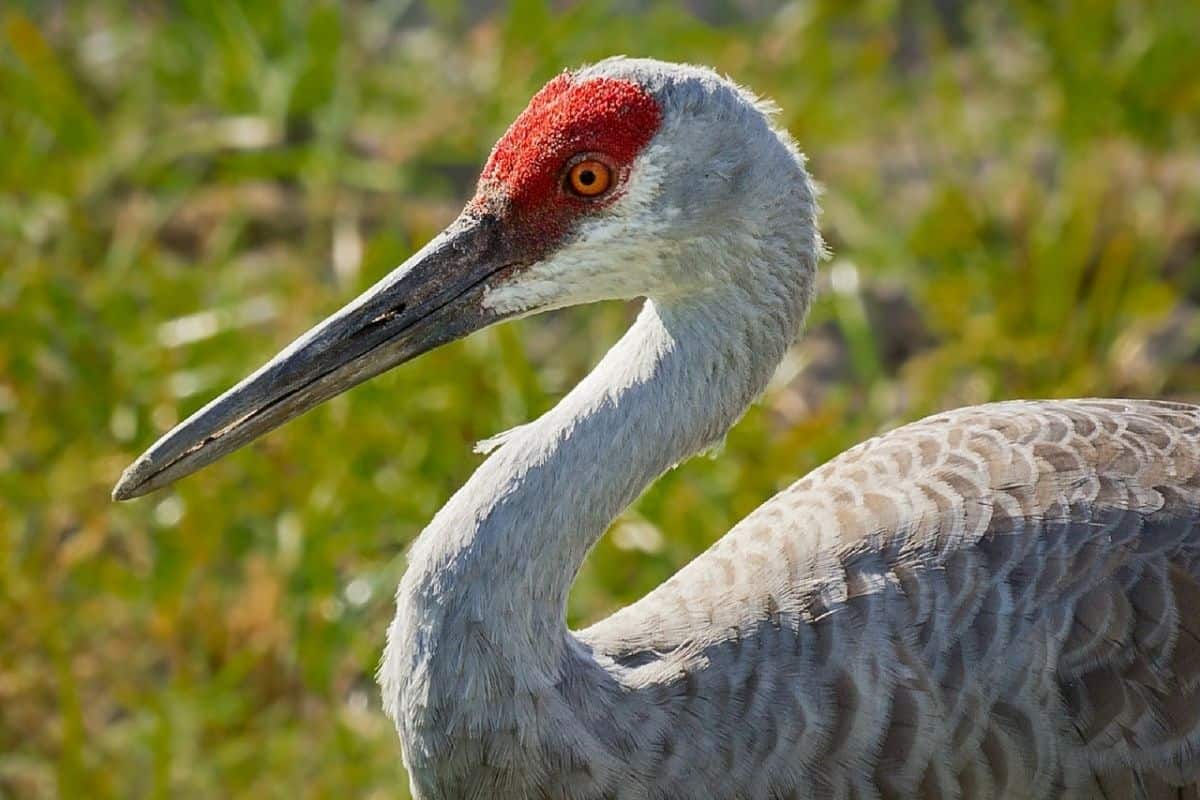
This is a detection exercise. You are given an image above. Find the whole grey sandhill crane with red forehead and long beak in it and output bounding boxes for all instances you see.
[114,59,1200,799]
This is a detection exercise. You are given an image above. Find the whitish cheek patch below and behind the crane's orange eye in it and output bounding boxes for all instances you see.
[482,145,686,313]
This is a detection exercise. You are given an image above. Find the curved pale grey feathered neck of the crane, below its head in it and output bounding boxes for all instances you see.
[380,245,809,766]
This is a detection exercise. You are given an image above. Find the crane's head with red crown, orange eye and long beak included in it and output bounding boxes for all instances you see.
[113,58,820,500]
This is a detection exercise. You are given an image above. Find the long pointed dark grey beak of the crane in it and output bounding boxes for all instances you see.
[113,212,524,500]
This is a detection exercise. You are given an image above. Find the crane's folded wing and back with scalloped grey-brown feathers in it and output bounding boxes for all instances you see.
[578,401,1200,799]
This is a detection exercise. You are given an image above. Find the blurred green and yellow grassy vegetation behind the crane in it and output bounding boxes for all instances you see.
[0,0,1200,798]
